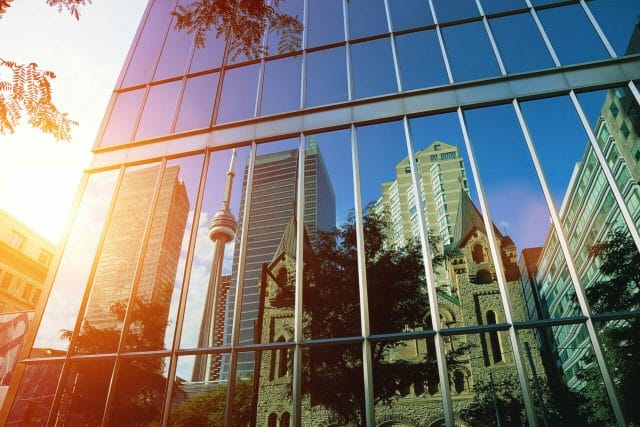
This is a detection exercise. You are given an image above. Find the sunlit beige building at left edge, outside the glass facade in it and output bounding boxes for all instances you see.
[0,209,56,313]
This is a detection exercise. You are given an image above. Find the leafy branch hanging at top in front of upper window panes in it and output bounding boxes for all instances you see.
[174,0,303,59]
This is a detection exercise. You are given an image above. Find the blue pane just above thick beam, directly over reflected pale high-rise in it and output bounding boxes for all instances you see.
[395,30,449,90]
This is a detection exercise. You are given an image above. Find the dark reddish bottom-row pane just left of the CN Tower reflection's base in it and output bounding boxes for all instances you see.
[109,357,169,426]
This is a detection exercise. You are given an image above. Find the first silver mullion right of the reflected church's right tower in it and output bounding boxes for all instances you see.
[513,99,626,426]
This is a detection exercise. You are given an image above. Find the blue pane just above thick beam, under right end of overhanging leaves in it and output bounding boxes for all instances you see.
[260,55,302,116]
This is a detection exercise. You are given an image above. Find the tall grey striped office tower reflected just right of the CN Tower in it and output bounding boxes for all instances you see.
[222,138,336,379]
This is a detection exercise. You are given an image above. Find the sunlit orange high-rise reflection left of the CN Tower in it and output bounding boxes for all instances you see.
[78,166,189,352]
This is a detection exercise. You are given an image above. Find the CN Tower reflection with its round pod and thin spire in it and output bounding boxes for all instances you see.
[193,149,237,382]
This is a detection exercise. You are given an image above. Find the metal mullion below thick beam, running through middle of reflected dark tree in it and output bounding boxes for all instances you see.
[351,125,376,426]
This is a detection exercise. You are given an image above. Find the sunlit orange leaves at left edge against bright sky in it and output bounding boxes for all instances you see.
[0,59,77,141]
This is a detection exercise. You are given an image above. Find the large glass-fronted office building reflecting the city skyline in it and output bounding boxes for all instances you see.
[0,0,640,426]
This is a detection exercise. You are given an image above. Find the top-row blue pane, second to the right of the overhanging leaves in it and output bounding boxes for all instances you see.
[347,0,389,39]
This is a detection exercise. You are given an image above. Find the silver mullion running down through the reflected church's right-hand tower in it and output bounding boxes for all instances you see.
[458,107,538,427]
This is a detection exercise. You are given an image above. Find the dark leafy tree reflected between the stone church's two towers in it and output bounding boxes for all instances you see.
[303,209,458,425]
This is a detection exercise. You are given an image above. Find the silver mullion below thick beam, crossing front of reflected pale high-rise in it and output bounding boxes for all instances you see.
[402,116,455,427]
